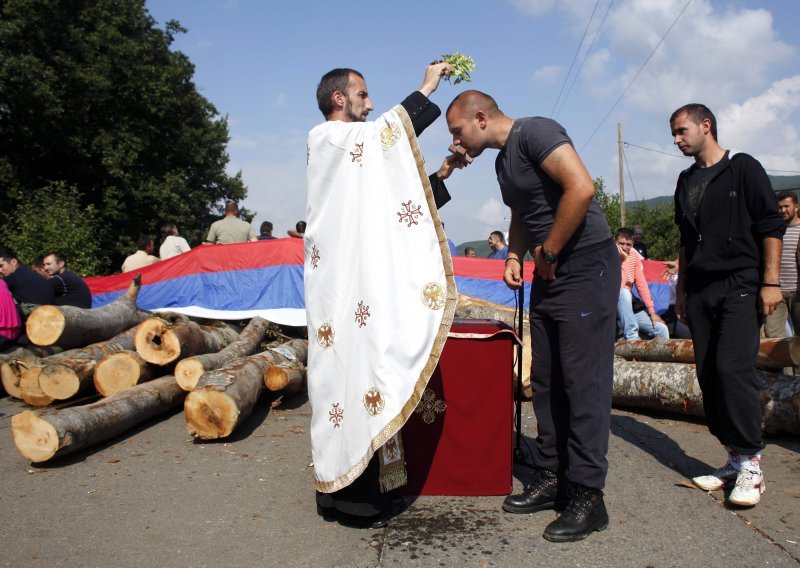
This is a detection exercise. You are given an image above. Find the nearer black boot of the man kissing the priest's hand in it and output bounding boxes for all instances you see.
[542,483,608,542]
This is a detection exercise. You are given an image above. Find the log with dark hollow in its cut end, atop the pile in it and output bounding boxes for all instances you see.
[134,317,238,365]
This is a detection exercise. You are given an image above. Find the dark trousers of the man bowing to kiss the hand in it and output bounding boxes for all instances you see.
[531,239,621,489]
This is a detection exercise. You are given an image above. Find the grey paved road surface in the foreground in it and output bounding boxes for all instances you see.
[0,398,800,568]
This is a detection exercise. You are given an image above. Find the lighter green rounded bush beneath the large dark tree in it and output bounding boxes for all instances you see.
[0,183,108,276]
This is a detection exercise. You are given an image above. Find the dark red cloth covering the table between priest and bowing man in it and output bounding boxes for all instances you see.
[400,319,515,495]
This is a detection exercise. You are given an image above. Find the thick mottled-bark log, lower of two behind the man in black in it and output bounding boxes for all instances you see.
[612,359,800,436]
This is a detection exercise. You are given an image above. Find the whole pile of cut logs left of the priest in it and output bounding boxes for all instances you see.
[0,277,308,463]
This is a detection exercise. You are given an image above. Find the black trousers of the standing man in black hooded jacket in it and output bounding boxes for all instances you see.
[686,268,764,455]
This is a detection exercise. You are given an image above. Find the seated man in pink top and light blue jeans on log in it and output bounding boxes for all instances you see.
[614,228,669,341]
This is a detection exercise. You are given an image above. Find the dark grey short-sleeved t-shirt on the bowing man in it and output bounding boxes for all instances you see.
[495,116,611,256]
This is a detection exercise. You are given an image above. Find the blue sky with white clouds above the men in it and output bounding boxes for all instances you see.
[147,0,800,247]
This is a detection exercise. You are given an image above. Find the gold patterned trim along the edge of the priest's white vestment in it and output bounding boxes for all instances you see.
[314,105,457,493]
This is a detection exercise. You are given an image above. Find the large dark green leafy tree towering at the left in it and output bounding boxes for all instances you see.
[0,0,246,266]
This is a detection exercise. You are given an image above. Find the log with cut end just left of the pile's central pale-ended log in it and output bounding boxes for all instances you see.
[39,327,137,400]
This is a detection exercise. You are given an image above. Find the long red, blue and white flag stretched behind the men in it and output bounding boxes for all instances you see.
[86,238,670,326]
